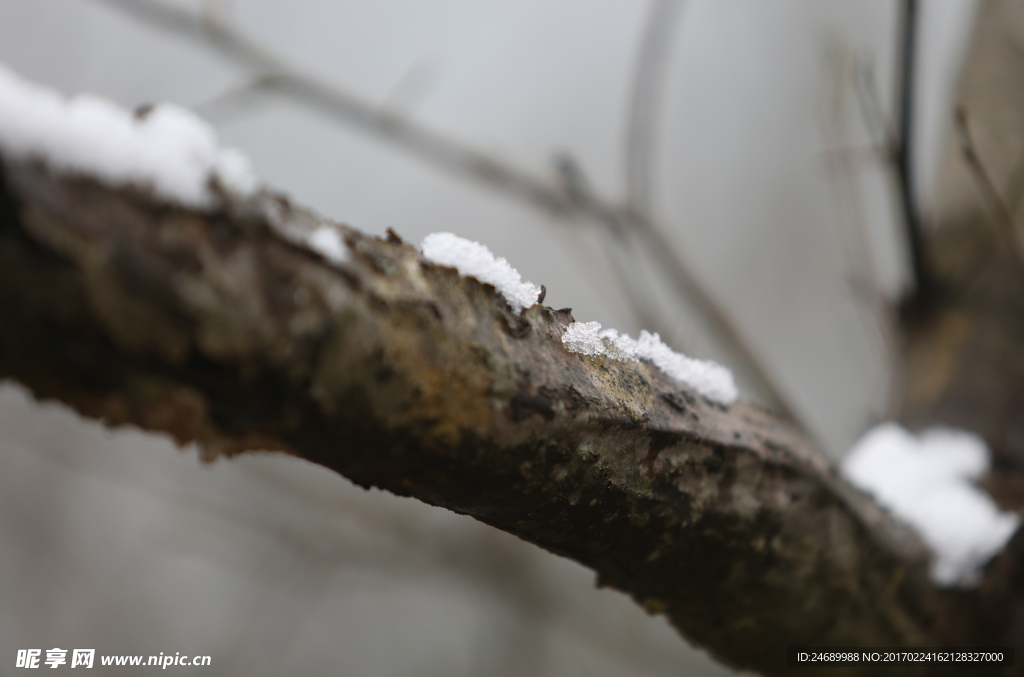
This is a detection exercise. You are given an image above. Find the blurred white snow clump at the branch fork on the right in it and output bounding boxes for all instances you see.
[843,423,1020,587]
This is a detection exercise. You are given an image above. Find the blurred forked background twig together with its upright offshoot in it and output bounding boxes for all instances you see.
[88,0,800,422]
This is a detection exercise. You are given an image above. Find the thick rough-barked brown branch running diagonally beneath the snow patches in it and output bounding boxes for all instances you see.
[0,150,1007,674]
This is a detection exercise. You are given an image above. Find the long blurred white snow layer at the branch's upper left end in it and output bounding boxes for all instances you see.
[0,65,258,208]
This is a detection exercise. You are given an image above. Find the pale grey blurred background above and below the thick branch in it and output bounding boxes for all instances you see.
[0,0,977,676]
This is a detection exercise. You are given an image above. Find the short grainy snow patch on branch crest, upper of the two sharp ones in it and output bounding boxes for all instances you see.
[420,232,541,312]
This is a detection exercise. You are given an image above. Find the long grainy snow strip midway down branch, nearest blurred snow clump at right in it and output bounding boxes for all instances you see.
[562,322,739,405]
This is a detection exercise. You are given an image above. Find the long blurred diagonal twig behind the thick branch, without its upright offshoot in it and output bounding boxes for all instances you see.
[88,0,806,428]
